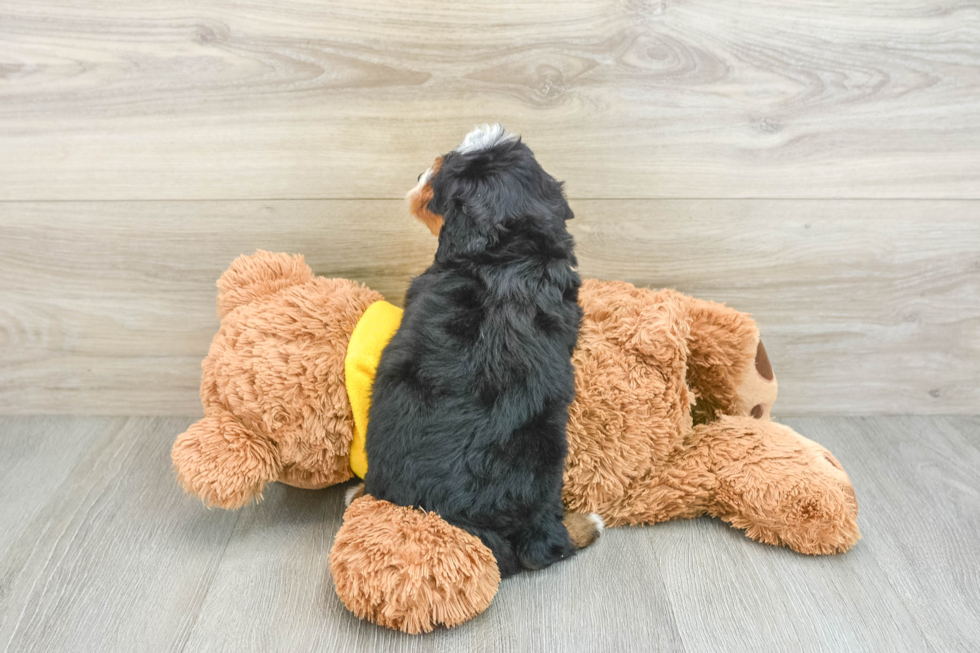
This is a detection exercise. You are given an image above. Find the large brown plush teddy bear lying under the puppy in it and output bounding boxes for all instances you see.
[172,251,860,633]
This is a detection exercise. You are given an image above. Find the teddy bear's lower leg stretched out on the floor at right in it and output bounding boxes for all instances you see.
[691,417,860,554]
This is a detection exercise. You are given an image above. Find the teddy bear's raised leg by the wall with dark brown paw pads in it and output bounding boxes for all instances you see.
[677,294,778,424]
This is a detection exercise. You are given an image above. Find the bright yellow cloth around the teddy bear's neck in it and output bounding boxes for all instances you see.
[344,301,404,478]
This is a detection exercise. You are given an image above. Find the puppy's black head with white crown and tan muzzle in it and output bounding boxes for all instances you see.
[408,125,573,246]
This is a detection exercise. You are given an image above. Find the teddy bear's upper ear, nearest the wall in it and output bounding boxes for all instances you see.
[218,249,313,318]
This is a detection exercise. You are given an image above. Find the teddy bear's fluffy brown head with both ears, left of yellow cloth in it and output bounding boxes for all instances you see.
[172,251,383,508]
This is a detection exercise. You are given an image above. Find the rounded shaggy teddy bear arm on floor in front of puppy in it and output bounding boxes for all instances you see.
[330,494,500,633]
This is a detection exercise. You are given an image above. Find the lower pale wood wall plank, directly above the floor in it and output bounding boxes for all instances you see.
[0,200,980,415]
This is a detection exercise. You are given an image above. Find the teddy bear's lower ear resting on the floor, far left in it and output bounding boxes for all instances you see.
[171,412,280,509]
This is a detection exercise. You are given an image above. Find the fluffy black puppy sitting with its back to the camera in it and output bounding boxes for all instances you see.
[364,125,602,577]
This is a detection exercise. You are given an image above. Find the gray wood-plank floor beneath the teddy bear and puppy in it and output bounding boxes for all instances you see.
[0,417,980,653]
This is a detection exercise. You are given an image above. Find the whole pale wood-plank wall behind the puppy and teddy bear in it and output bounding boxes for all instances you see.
[0,0,980,415]
